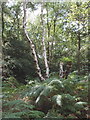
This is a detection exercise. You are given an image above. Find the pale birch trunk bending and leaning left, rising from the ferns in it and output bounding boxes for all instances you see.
[23,1,45,81]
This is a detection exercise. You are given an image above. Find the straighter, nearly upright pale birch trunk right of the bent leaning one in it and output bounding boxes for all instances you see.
[41,2,49,78]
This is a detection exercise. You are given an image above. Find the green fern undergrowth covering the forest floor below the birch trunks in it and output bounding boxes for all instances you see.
[2,73,88,118]
